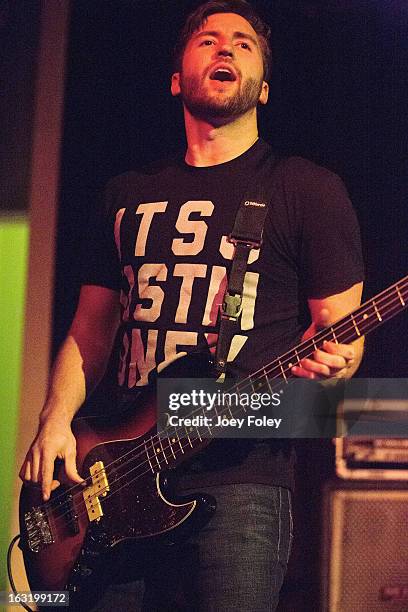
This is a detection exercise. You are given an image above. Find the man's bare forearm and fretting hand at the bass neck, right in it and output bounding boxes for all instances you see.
[292,282,364,379]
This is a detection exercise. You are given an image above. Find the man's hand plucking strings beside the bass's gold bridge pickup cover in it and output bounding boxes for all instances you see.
[20,416,84,501]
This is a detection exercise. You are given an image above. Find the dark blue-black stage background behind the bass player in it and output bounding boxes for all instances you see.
[54,0,408,610]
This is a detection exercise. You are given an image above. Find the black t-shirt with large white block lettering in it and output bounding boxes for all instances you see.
[82,140,363,487]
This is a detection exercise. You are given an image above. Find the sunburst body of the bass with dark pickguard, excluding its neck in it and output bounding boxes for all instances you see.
[20,358,215,610]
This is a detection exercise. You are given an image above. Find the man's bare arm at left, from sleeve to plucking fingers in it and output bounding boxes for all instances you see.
[20,285,119,500]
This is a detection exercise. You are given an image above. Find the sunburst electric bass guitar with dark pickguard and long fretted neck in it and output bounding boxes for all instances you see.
[20,276,408,610]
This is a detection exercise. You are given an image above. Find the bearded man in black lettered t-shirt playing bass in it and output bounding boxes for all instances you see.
[21,0,362,612]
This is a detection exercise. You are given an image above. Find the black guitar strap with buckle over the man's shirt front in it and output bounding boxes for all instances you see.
[215,150,279,380]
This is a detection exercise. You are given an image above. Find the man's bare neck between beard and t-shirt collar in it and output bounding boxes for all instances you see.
[184,108,258,166]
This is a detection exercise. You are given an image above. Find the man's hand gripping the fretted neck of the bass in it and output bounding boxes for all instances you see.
[292,308,356,379]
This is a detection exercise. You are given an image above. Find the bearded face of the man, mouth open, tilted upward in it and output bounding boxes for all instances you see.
[172,13,268,120]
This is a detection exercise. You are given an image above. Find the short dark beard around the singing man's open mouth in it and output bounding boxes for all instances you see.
[180,75,263,119]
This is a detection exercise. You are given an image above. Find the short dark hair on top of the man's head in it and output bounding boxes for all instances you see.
[174,0,272,80]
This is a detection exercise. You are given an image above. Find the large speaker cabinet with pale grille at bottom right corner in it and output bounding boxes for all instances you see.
[321,481,408,612]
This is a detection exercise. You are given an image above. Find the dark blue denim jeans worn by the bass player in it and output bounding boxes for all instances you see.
[94,484,293,612]
